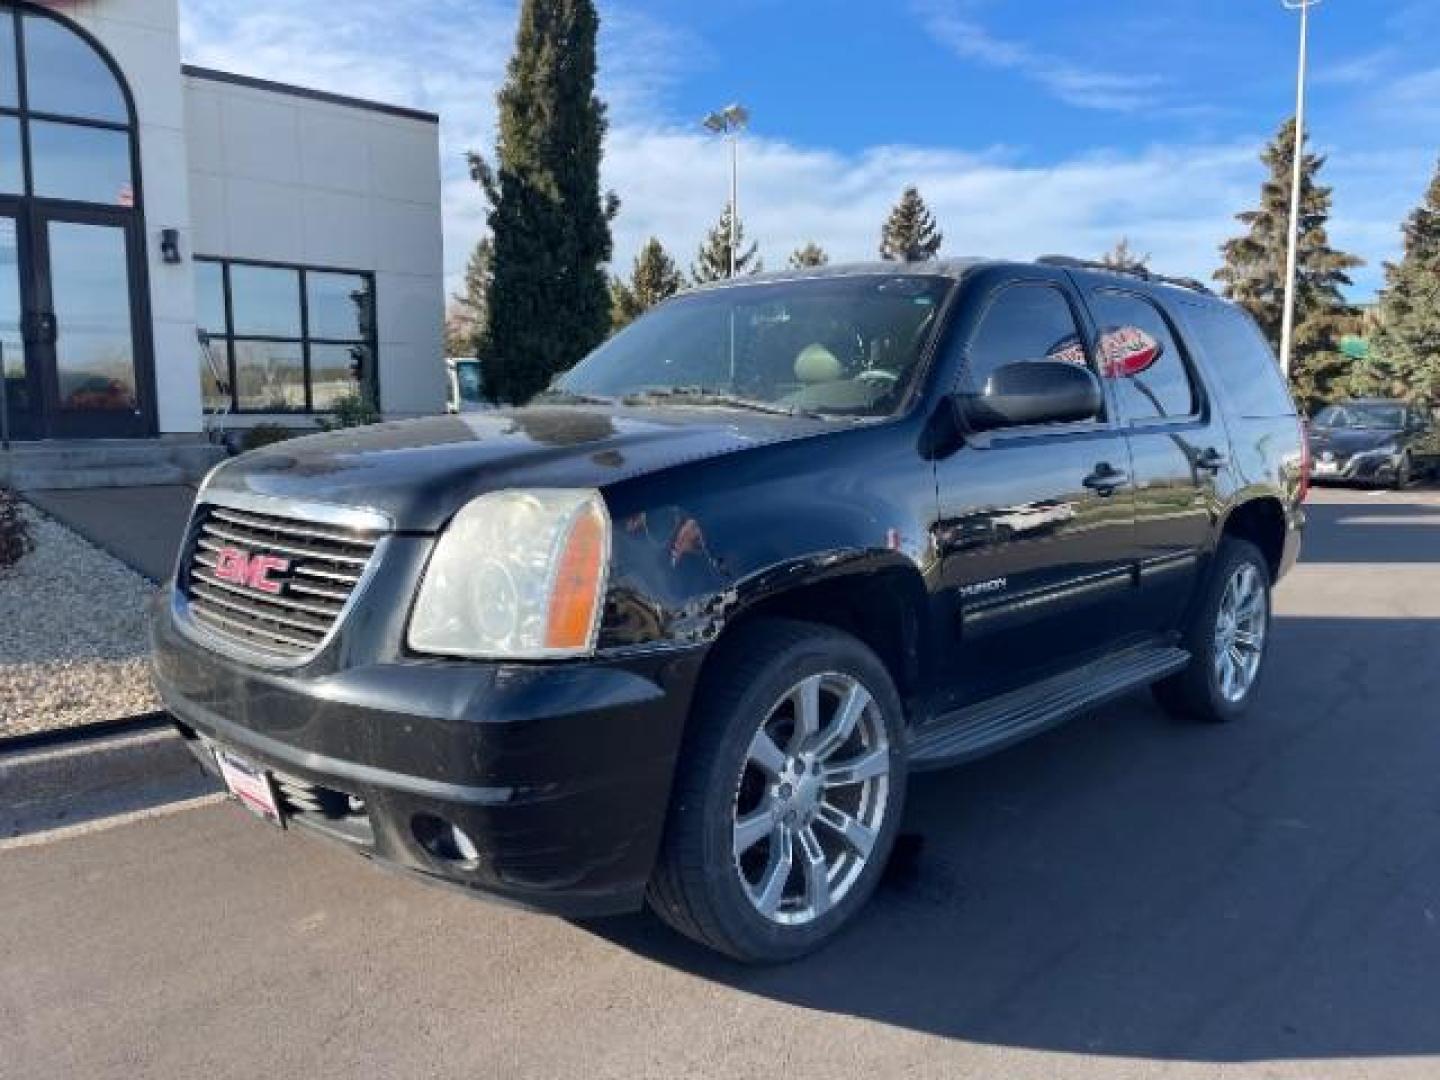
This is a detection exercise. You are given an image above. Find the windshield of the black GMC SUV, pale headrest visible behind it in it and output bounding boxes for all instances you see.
[550,274,953,416]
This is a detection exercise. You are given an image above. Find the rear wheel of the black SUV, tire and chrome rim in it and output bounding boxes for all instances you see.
[1152,536,1272,723]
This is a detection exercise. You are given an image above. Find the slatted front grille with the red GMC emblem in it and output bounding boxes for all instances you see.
[180,505,382,660]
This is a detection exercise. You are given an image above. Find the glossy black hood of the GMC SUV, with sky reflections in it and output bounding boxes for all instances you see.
[206,406,832,531]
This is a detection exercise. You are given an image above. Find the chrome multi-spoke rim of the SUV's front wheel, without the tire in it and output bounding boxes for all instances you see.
[733,671,890,926]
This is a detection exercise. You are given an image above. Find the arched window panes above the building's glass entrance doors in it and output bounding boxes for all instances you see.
[0,4,135,206]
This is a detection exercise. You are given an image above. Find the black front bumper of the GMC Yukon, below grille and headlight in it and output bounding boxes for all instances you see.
[151,595,701,916]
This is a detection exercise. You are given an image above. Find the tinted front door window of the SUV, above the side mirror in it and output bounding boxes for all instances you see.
[960,284,1086,393]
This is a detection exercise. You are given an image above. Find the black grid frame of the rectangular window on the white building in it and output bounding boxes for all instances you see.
[194,255,380,416]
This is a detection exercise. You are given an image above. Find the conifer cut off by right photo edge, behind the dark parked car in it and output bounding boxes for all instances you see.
[1351,158,1440,403]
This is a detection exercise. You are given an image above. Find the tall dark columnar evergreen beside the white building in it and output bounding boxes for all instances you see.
[469,0,619,403]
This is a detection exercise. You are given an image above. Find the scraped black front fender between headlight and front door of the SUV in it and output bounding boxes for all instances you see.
[600,423,936,659]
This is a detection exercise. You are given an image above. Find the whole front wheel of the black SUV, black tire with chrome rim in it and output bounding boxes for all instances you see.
[648,619,906,963]
